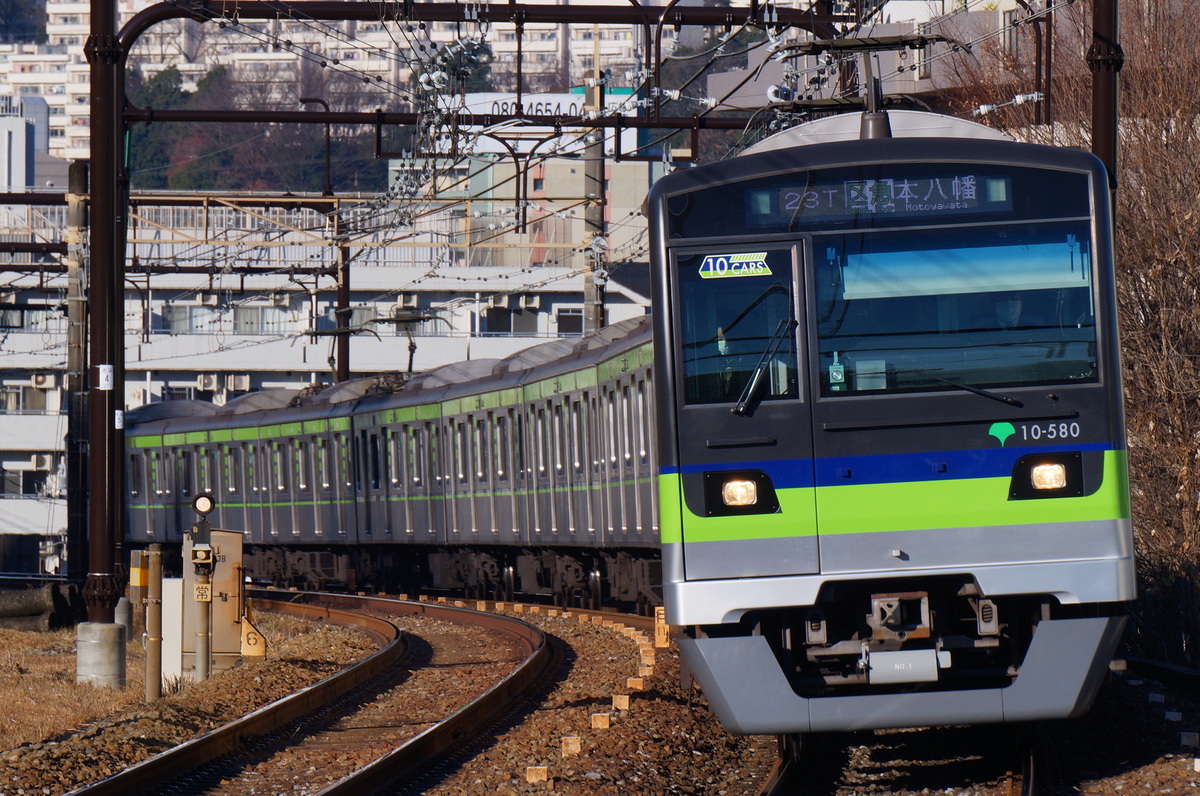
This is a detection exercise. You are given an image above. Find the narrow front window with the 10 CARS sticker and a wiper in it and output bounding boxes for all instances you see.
[676,247,798,406]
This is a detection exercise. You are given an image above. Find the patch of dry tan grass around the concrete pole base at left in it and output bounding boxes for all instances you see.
[0,628,145,750]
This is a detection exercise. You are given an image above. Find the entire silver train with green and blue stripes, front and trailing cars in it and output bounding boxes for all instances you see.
[126,110,1135,738]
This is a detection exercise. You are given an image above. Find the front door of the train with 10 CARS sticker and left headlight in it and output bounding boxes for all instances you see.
[664,244,818,580]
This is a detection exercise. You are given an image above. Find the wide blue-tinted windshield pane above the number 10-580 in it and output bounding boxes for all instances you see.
[814,222,1098,396]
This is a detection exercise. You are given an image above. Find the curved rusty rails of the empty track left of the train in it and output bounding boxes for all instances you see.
[65,591,554,796]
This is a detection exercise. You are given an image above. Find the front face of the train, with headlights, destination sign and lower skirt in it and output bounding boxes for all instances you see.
[648,114,1134,734]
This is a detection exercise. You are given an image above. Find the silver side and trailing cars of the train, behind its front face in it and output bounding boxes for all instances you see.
[126,318,660,609]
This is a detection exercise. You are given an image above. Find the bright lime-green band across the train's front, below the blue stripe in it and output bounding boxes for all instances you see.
[659,450,1129,544]
